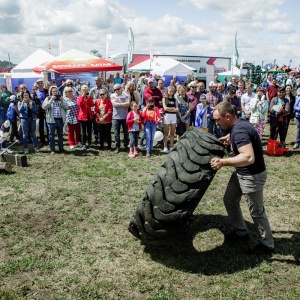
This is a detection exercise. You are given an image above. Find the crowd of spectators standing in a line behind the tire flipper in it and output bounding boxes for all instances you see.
[0,73,300,158]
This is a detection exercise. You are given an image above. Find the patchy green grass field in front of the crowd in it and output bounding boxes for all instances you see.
[0,123,300,300]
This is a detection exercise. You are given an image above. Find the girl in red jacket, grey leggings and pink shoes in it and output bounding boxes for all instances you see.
[126,102,142,158]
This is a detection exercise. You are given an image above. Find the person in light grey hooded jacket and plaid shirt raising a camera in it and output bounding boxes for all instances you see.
[42,86,68,155]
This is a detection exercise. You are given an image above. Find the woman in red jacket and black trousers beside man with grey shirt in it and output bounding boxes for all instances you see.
[95,89,113,150]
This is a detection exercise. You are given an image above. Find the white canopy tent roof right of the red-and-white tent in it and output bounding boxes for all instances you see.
[127,57,196,76]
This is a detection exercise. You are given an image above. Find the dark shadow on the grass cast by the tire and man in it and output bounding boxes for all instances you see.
[145,215,300,275]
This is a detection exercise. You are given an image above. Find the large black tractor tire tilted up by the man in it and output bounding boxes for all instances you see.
[128,127,225,246]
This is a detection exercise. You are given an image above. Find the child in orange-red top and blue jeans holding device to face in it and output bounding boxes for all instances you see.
[142,97,160,157]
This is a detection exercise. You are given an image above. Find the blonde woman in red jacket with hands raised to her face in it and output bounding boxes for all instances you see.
[77,85,95,150]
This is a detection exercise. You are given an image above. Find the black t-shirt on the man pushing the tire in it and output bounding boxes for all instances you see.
[230,119,266,175]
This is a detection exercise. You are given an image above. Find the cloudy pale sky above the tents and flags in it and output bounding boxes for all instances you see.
[0,0,300,66]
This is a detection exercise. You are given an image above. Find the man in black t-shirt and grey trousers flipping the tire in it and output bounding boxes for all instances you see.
[211,102,274,255]
